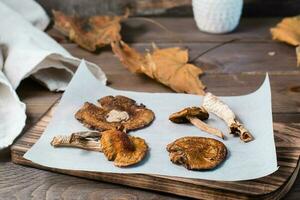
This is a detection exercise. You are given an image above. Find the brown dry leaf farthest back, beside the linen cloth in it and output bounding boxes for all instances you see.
[53,10,129,52]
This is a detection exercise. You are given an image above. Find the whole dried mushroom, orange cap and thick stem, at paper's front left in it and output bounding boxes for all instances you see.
[51,130,148,167]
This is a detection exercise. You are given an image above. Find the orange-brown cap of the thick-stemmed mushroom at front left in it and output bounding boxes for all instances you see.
[100,130,148,167]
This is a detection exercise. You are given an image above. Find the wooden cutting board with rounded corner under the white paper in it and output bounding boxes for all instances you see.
[11,105,300,199]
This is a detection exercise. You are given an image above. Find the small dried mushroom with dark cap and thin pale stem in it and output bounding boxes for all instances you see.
[169,107,224,139]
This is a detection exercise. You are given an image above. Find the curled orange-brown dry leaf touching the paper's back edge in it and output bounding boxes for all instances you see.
[112,41,205,95]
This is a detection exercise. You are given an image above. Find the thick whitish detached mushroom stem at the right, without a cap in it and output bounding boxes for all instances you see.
[203,93,254,142]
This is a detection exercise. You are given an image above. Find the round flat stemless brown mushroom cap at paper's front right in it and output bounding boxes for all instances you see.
[167,137,227,170]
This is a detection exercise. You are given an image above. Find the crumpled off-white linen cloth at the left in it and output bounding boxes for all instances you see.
[0,0,106,149]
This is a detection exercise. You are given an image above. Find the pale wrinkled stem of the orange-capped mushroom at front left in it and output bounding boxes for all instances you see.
[51,131,102,152]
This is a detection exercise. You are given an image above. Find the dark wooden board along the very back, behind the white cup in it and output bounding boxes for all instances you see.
[37,0,300,17]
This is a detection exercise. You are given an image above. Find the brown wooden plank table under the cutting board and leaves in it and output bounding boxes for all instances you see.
[0,18,300,199]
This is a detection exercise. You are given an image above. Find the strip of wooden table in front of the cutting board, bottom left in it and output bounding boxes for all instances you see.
[0,162,182,200]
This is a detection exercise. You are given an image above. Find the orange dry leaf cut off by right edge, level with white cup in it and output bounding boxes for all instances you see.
[271,16,300,46]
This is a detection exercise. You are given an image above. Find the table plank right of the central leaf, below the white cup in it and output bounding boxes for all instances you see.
[195,42,300,72]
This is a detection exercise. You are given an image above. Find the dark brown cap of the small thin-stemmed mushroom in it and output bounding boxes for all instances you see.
[169,107,209,123]
